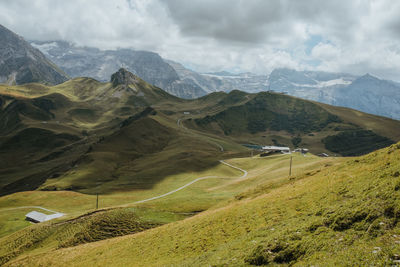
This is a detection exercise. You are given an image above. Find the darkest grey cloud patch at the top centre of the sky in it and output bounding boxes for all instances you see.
[165,0,284,43]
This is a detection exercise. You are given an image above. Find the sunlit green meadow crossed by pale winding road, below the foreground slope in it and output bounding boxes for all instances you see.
[0,154,341,263]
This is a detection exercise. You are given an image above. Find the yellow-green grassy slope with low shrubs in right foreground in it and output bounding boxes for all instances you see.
[8,143,400,266]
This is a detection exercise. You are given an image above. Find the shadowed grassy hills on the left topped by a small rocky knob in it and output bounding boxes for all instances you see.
[0,70,246,197]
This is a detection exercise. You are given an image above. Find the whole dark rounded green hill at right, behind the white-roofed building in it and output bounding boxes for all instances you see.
[186,91,400,156]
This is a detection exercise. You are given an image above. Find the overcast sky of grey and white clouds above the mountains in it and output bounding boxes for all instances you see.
[0,0,400,81]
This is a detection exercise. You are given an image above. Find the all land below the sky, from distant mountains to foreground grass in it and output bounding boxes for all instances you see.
[0,19,400,266]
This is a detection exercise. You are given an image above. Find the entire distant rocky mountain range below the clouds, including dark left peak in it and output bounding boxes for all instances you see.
[0,23,400,119]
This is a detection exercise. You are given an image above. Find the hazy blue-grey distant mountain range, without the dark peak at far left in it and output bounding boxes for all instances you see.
[31,41,400,119]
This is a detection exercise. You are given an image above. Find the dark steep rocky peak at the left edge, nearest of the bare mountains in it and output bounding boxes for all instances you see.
[0,25,68,84]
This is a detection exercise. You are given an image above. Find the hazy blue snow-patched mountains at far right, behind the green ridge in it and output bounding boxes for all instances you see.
[269,69,400,119]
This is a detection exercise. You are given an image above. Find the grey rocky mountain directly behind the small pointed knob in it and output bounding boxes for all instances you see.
[31,41,206,98]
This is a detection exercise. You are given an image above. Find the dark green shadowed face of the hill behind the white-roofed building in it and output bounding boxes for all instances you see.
[196,93,341,135]
